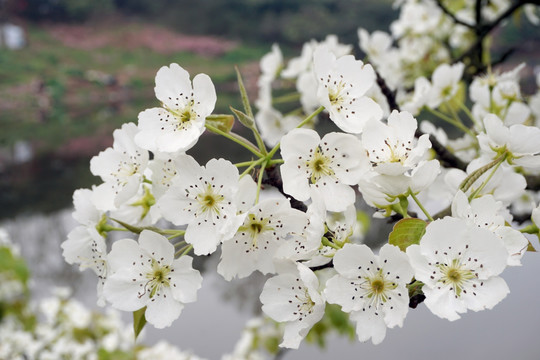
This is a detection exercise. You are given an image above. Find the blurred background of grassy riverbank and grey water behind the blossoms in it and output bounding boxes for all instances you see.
[0,0,540,359]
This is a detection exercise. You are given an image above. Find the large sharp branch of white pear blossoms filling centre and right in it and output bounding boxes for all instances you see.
[62,0,540,348]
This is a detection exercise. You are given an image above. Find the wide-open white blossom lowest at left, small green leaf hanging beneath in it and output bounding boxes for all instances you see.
[103,230,202,328]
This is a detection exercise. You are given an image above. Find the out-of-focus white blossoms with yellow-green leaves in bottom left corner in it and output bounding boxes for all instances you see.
[0,232,202,360]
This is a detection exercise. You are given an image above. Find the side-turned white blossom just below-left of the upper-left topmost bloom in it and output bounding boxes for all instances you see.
[90,123,148,211]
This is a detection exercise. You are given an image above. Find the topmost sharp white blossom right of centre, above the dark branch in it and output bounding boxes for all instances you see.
[313,47,383,134]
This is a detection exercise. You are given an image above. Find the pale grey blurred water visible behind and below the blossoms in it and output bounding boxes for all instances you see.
[0,209,540,360]
